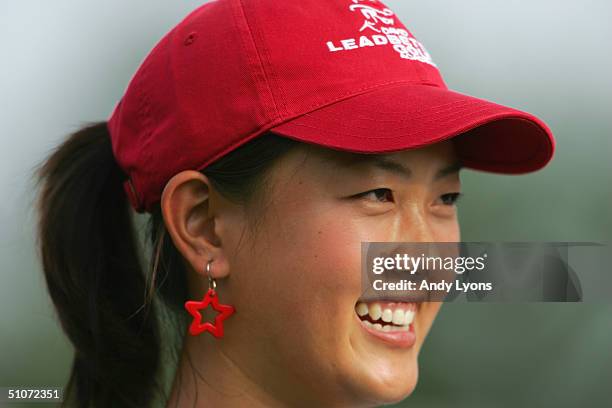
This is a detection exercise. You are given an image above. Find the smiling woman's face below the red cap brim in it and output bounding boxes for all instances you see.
[170,142,460,406]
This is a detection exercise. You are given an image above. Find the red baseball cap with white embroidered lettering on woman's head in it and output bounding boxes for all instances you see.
[108,0,555,212]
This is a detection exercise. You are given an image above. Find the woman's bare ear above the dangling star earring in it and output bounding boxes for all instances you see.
[161,170,229,278]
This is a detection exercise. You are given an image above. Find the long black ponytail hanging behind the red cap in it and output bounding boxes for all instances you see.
[36,122,160,408]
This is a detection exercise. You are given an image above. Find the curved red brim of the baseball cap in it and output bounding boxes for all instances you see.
[270,84,555,174]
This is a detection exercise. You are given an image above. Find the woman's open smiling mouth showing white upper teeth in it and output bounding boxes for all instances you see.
[355,301,418,348]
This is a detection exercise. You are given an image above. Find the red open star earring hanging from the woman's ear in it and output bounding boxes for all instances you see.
[185,261,235,338]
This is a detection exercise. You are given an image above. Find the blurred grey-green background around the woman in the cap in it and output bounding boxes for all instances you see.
[0,0,612,407]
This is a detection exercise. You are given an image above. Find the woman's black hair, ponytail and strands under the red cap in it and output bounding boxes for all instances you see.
[35,122,299,408]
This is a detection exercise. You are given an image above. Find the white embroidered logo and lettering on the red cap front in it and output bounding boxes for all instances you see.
[326,0,436,67]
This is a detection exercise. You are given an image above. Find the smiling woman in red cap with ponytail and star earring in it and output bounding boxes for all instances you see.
[38,0,554,407]
